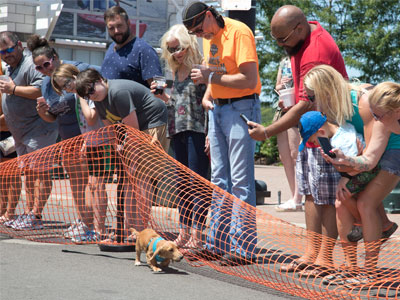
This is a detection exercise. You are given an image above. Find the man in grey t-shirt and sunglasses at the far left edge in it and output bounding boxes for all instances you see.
[0,31,58,229]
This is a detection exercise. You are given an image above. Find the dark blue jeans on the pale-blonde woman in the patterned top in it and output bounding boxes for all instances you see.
[172,130,210,229]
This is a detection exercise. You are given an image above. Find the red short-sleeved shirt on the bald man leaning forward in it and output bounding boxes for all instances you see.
[291,21,348,147]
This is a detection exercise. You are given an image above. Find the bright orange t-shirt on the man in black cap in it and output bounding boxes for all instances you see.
[203,18,261,99]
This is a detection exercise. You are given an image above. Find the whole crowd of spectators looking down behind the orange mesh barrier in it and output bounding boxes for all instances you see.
[0,1,400,274]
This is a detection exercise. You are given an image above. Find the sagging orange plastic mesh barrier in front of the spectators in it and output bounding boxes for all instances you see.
[0,125,400,299]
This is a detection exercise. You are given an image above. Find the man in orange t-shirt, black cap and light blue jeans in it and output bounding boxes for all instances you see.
[182,2,261,265]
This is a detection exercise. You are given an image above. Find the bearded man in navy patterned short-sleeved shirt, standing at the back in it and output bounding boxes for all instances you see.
[101,6,162,88]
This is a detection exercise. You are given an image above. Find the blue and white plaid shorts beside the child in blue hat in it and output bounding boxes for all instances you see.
[296,147,340,205]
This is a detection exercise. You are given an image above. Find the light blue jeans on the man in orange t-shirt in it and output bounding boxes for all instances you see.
[206,99,261,256]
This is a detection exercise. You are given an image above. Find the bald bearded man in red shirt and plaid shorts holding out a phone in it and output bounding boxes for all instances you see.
[249,5,348,271]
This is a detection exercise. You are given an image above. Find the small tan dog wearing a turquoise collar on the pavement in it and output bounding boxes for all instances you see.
[129,228,183,272]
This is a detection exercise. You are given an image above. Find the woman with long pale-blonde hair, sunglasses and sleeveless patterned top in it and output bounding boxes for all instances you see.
[151,24,209,248]
